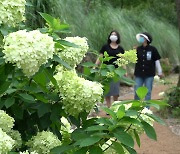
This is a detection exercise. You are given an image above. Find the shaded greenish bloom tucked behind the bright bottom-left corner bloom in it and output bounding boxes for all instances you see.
[7,130,22,150]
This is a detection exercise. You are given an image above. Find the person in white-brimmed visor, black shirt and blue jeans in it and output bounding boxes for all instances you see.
[134,32,163,100]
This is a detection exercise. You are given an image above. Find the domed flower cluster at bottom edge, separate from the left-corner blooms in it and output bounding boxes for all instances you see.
[27,131,61,154]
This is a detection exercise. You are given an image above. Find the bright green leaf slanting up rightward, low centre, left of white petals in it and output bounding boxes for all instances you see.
[80,136,101,147]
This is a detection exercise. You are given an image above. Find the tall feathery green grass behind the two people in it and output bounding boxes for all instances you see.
[26,0,180,64]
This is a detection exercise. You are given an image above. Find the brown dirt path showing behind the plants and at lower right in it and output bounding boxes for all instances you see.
[96,75,180,154]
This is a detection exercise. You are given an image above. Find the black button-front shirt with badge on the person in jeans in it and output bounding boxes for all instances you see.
[134,45,161,77]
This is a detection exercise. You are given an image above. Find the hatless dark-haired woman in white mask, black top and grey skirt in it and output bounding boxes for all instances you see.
[96,30,124,107]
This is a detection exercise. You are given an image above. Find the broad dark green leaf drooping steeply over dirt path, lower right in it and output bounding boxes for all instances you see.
[141,121,157,140]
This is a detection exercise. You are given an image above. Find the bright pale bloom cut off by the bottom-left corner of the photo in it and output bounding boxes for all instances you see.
[0,128,15,154]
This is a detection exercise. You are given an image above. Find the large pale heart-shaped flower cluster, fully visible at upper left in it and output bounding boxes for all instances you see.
[3,30,55,77]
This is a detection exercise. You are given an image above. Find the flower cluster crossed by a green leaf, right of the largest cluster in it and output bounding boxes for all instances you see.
[58,36,89,67]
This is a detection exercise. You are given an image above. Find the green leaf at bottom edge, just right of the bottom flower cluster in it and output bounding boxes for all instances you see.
[50,145,74,154]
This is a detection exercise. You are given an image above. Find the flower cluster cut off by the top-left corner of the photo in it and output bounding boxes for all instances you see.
[0,0,26,27]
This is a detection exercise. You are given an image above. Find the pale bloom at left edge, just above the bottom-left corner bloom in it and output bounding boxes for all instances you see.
[0,110,14,132]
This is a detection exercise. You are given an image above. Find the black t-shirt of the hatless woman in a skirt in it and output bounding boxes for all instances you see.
[100,44,124,68]
